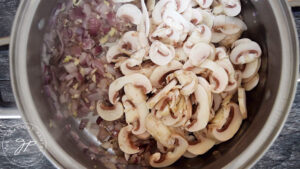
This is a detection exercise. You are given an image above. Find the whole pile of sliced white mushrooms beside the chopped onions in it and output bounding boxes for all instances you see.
[97,0,262,167]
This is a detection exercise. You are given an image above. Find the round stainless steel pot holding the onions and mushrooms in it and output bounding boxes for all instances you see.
[3,0,299,169]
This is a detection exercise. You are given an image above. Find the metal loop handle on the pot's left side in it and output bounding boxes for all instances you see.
[0,37,21,119]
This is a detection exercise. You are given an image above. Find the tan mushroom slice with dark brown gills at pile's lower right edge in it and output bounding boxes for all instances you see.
[208,103,243,142]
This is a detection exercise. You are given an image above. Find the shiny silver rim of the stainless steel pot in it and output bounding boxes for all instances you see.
[10,0,299,168]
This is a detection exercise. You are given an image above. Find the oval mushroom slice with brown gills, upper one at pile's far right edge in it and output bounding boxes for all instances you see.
[230,41,261,64]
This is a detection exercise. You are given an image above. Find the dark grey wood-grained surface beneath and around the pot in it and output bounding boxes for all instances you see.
[0,0,300,169]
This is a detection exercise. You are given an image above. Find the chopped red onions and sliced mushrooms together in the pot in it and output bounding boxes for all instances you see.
[43,0,262,167]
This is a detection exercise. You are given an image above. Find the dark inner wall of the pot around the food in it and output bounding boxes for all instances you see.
[27,0,282,168]
